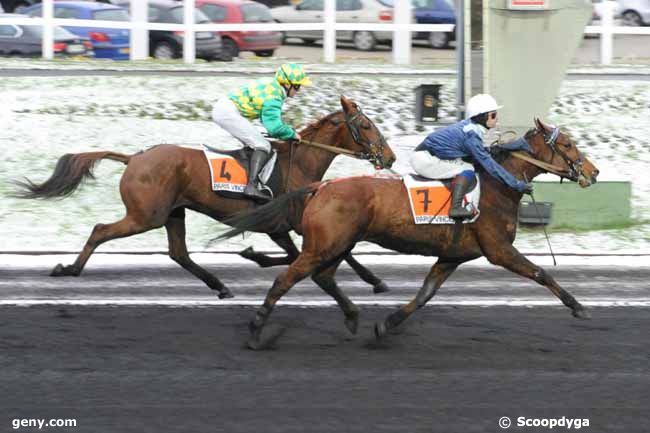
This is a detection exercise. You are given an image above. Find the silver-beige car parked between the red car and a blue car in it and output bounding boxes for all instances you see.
[271,0,393,51]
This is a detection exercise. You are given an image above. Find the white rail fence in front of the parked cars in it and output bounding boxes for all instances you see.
[0,0,650,65]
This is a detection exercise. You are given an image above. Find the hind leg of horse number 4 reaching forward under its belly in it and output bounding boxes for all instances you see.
[165,208,233,299]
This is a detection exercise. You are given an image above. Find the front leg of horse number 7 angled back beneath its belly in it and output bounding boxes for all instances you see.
[375,260,460,339]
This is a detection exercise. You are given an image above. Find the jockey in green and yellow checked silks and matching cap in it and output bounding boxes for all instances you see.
[212,63,311,200]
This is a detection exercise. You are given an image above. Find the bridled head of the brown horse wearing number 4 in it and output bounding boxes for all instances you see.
[341,95,396,168]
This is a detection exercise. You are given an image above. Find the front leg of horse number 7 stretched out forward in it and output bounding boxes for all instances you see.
[483,241,590,319]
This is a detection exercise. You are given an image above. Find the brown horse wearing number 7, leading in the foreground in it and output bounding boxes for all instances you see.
[223,119,598,349]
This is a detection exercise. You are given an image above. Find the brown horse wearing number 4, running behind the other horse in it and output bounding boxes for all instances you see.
[17,96,395,298]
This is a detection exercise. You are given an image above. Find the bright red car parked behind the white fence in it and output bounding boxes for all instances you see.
[196,0,282,57]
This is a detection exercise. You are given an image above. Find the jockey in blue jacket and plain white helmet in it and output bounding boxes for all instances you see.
[410,94,533,220]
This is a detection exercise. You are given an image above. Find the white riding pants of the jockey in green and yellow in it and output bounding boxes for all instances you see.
[212,96,271,153]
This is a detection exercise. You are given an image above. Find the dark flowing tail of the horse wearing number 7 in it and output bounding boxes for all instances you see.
[219,184,318,240]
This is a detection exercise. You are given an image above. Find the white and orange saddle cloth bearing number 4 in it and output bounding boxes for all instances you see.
[203,145,281,198]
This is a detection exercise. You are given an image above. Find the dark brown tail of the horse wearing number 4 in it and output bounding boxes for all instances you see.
[14,151,133,199]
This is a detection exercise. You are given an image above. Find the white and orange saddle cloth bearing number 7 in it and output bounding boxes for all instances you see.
[402,174,481,224]
